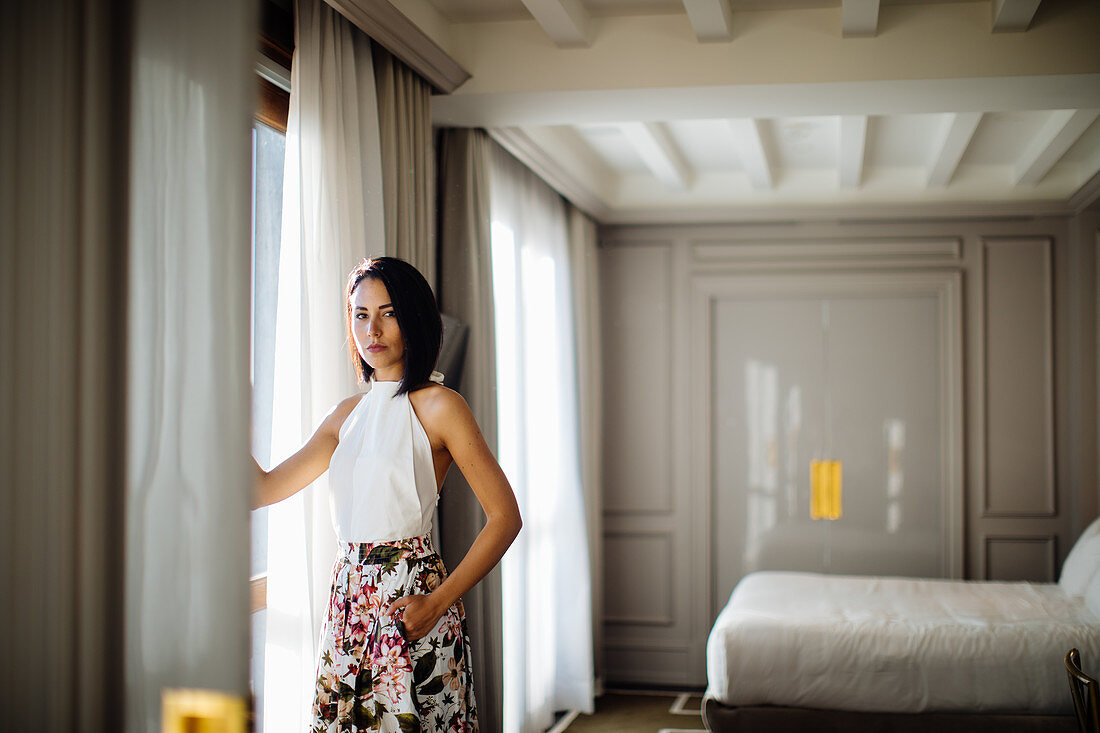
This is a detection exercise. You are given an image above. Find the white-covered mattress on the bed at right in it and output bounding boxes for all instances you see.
[706,572,1100,714]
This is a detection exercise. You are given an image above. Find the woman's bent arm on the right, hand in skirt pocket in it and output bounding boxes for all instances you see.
[388,390,523,639]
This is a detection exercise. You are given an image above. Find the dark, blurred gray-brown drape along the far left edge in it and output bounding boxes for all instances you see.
[0,0,131,731]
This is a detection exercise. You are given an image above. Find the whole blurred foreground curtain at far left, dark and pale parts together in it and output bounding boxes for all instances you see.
[0,0,255,731]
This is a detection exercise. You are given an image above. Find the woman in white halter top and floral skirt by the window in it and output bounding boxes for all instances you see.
[255,258,520,733]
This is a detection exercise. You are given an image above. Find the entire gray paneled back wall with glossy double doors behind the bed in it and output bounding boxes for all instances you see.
[601,218,1098,685]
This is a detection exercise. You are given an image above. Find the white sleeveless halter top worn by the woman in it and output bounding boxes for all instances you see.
[329,373,439,543]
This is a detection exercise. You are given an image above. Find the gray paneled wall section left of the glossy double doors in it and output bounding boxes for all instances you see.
[600,241,695,682]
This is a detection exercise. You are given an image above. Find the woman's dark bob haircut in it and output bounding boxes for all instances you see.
[344,258,443,394]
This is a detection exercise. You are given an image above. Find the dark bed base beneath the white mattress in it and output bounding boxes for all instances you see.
[703,698,1077,733]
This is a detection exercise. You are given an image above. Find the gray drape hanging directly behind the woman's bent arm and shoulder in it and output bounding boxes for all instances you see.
[437,130,504,733]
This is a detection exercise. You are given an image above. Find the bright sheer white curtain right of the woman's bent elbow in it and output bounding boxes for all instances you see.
[490,145,593,733]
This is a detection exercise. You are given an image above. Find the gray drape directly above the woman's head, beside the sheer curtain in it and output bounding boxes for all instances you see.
[370,44,436,283]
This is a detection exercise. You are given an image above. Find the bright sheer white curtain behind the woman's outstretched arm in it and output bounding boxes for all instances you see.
[263,0,385,721]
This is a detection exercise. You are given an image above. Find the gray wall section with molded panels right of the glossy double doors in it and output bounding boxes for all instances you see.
[970,236,1071,581]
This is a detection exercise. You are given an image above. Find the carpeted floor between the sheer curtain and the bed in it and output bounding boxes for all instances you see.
[563,690,705,733]
